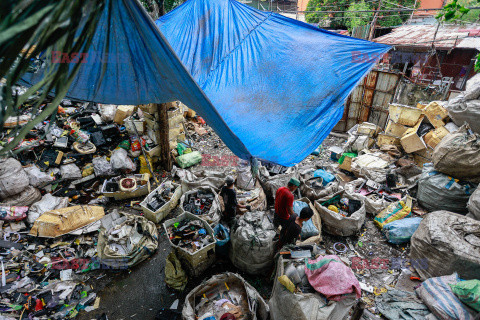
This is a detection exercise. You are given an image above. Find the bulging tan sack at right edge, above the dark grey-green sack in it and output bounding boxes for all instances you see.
[432,126,480,182]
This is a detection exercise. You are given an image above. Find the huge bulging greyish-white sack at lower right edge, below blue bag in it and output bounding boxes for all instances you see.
[410,211,480,280]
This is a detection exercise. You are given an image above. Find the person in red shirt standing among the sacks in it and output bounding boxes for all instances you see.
[273,178,300,228]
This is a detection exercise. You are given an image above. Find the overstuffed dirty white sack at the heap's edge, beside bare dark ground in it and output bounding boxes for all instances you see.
[97,210,158,268]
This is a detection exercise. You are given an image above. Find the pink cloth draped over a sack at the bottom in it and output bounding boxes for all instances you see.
[305,256,362,301]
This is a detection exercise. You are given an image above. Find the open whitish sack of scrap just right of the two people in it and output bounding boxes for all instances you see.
[315,189,366,236]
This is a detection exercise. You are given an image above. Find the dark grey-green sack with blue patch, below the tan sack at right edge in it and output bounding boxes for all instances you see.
[417,163,477,213]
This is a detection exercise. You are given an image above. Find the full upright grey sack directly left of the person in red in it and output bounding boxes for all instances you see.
[229,211,276,274]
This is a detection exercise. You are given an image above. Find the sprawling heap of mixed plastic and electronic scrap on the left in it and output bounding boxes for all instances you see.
[0,100,203,319]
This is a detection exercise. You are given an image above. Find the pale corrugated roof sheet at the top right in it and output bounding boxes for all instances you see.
[374,25,480,49]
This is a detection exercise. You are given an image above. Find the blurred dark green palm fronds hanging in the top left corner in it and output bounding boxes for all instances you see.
[0,0,105,154]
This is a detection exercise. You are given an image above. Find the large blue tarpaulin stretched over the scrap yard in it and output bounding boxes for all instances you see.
[25,0,389,166]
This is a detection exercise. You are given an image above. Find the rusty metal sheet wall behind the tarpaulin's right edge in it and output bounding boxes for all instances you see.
[333,70,400,131]
